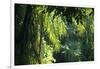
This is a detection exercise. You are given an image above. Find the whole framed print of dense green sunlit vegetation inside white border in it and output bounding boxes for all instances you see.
[15,4,94,65]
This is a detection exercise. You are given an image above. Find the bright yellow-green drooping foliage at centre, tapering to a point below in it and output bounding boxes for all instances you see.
[44,10,66,51]
